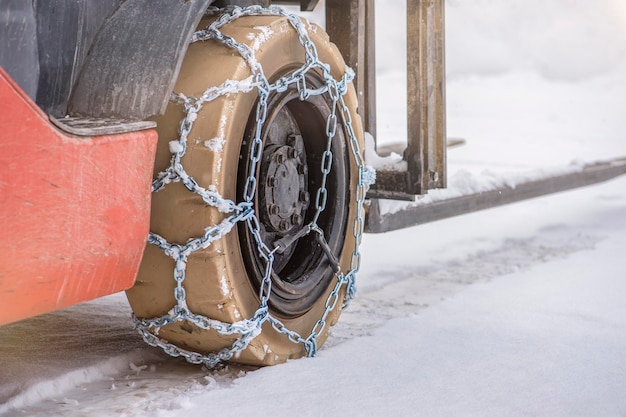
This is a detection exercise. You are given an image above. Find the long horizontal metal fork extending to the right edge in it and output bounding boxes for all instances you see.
[365,157,626,233]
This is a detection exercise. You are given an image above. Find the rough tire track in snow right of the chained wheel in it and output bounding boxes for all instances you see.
[324,232,601,348]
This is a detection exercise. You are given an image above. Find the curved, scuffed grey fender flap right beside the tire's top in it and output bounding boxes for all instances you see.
[68,0,214,119]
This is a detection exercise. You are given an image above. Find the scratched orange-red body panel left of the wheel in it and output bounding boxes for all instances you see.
[0,68,157,324]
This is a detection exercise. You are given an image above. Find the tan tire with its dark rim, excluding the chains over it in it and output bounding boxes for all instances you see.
[127,11,363,365]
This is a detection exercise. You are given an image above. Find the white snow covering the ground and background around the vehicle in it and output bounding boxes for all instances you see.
[0,0,626,417]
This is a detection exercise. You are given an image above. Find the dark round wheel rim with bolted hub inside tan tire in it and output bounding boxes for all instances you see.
[237,71,349,318]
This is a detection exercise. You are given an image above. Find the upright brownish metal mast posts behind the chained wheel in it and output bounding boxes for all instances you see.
[326,0,446,200]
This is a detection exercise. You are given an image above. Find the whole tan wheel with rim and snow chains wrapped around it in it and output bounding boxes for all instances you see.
[127,9,363,365]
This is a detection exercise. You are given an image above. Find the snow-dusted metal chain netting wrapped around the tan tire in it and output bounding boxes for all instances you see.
[133,6,375,368]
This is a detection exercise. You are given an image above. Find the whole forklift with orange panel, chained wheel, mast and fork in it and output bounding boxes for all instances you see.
[0,0,626,367]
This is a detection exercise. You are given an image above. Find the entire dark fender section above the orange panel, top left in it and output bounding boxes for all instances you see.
[0,0,308,119]
